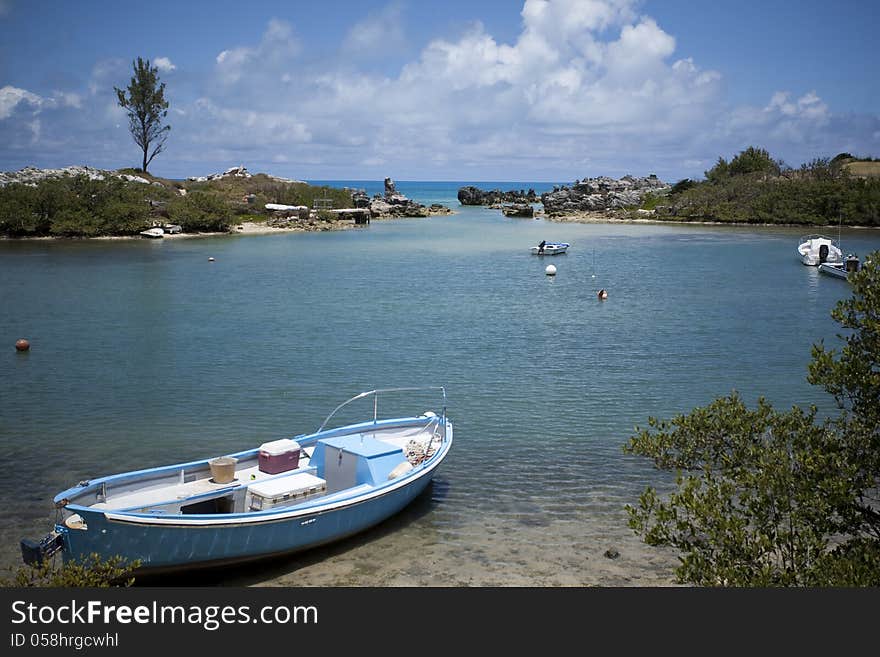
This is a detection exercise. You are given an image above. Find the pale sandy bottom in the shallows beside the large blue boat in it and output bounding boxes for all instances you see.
[148,493,678,587]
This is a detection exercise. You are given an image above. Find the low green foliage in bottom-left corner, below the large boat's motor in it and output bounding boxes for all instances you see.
[0,554,140,588]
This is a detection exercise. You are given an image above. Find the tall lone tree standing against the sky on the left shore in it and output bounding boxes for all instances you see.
[113,57,171,173]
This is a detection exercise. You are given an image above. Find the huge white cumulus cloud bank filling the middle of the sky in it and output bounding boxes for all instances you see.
[160,0,736,176]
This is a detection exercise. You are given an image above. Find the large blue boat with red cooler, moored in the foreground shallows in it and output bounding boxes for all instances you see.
[21,387,452,572]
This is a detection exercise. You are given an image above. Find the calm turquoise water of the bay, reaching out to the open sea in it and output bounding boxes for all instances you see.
[0,181,880,586]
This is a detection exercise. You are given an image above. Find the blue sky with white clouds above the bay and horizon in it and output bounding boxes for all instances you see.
[0,0,880,181]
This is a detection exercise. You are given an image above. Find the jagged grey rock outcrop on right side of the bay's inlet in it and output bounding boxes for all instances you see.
[541,174,669,216]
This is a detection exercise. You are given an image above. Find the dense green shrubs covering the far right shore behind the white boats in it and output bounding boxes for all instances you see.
[640,147,880,226]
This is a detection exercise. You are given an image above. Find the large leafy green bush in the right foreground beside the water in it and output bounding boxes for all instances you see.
[624,252,880,586]
